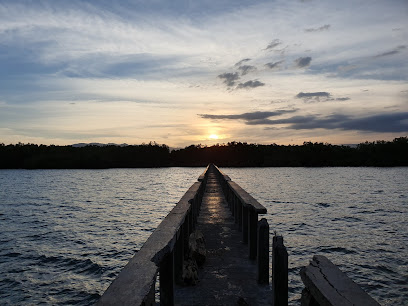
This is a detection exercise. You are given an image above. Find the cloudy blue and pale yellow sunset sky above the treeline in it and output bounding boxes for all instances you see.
[0,0,408,147]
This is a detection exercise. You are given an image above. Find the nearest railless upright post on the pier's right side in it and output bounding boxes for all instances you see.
[272,236,288,306]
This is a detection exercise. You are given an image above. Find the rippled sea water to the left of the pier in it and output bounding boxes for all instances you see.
[0,168,204,305]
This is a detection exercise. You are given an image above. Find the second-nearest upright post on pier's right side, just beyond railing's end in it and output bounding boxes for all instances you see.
[258,218,269,285]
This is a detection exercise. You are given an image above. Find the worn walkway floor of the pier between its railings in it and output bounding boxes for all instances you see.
[175,171,272,305]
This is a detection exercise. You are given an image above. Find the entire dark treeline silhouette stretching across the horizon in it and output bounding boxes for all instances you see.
[0,137,408,169]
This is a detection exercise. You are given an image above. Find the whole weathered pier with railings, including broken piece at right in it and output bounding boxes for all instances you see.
[97,164,379,306]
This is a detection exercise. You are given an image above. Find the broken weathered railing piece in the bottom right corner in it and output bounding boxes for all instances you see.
[300,255,380,306]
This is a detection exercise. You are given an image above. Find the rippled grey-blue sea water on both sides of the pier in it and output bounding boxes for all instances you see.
[0,168,408,305]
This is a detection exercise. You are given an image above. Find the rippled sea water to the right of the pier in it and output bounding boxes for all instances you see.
[223,168,408,305]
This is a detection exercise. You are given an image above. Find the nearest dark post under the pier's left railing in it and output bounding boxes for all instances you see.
[160,251,174,306]
